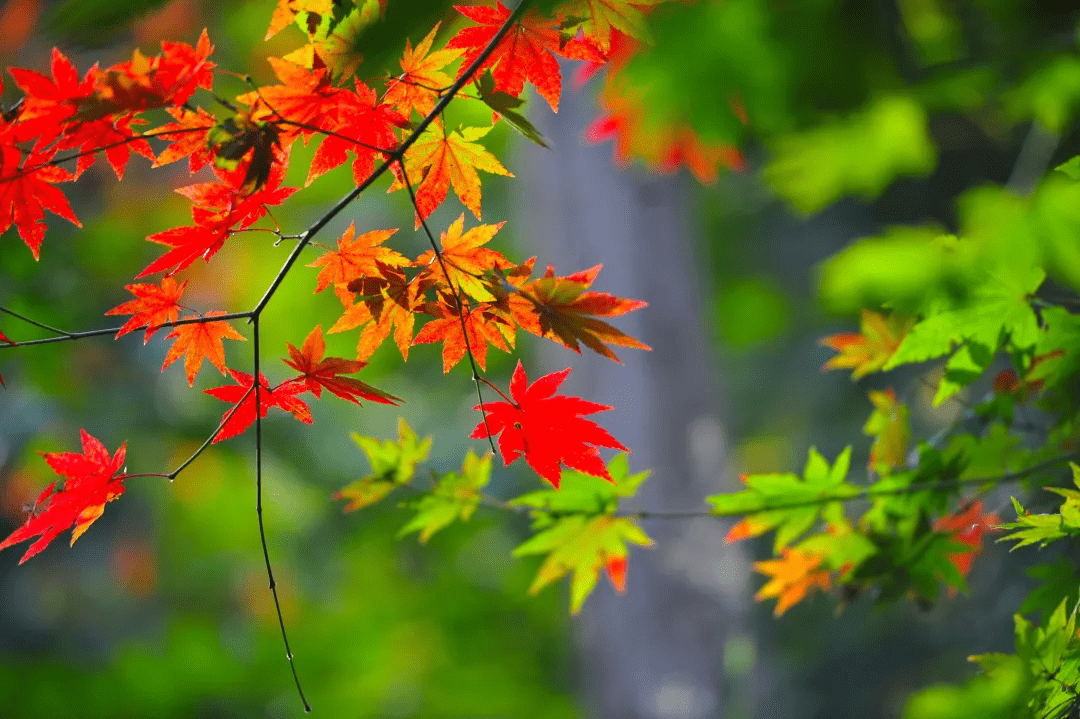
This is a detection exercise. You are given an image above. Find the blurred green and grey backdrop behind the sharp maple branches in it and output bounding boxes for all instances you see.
[0,0,1080,719]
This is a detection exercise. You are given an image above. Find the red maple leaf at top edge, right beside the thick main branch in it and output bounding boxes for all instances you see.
[446,2,604,112]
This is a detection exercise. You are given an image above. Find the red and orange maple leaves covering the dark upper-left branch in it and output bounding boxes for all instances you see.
[0,0,648,578]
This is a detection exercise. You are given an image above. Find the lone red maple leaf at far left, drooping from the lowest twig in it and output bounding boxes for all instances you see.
[0,430,127,564]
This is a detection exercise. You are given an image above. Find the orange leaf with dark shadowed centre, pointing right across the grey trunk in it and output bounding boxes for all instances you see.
[509,264,651,363]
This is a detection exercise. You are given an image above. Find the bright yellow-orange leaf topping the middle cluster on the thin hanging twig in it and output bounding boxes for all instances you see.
[416,215,515,302]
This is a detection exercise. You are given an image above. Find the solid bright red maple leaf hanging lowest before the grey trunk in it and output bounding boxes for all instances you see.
[469,361,630,489]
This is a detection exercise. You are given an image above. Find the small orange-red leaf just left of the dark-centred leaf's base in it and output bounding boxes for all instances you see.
[413,297,514,374]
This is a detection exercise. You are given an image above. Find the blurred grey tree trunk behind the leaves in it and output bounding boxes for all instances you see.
[514,80,754,719]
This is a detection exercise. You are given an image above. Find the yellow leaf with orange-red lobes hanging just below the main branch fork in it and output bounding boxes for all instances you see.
[390,122,514,227]
